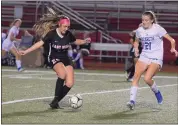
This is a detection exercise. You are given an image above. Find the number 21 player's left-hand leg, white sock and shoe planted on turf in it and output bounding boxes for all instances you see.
[127,61,148,110]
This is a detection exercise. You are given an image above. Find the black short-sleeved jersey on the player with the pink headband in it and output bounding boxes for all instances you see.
[42,29,76,58]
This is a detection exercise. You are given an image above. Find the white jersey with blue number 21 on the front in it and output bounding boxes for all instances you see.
[136,24,167,60]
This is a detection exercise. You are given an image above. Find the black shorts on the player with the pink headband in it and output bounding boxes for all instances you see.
[48,57,72,68]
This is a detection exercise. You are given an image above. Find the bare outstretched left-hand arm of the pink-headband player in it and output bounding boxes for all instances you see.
[19,40,44,55]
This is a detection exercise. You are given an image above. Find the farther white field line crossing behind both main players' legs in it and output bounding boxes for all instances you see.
[2,69,178,79]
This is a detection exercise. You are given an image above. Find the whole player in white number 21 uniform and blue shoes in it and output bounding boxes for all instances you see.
[127,11,178,110]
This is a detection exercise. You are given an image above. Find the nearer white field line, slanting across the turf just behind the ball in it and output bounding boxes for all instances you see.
[2,84,178,105]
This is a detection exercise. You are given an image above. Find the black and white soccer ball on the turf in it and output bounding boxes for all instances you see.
[69,94,83,109]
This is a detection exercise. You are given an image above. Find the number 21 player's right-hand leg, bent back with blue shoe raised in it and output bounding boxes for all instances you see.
[144,63,163,104]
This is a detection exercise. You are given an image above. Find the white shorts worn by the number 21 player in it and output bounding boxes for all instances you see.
[138,55,163,69]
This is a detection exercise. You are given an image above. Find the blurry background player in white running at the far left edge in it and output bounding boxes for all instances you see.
[1,19,23,71]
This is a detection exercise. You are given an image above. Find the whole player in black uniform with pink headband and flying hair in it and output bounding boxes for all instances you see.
[19,15,91,109]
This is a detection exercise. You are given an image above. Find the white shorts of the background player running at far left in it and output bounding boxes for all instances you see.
[2,39,16,52]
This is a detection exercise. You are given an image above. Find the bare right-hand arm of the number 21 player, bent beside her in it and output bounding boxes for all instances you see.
[163,34,178,57]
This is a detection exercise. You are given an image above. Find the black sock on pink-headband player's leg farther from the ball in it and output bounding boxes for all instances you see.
[55,78,64,97]
